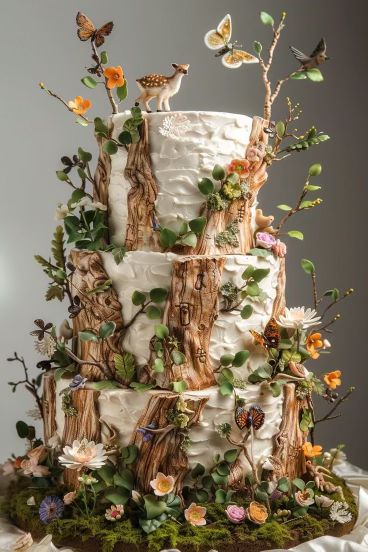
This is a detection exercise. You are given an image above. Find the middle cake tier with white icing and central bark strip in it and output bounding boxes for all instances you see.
[100,251,285,389]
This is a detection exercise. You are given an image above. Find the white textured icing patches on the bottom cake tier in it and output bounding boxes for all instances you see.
[56,380,284,474]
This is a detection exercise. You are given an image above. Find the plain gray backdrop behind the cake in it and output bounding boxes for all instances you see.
[0,0,368,468]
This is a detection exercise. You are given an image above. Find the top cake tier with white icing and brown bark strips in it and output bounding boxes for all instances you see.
[97,111,267,254]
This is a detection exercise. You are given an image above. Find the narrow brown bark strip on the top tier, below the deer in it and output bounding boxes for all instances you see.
[124,119,159,251]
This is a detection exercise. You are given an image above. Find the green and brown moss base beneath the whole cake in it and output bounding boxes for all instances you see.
[2,478,358,552]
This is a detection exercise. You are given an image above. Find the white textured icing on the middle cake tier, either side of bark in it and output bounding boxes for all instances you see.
[101,251,280,378]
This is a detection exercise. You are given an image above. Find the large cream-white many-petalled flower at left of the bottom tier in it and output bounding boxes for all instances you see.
[59,439,107,470]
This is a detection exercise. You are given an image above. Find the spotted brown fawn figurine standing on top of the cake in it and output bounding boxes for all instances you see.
[135,63,189,113]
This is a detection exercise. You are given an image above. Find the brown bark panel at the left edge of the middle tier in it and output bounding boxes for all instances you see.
[70,249,123,380]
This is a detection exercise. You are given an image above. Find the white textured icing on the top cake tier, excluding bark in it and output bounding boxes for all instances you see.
[109,111,256,245]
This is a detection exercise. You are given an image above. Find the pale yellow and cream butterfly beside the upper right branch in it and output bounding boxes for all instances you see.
[204,14,259,69]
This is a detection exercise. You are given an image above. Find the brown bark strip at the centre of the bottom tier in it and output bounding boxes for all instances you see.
[131,393,208,493]
